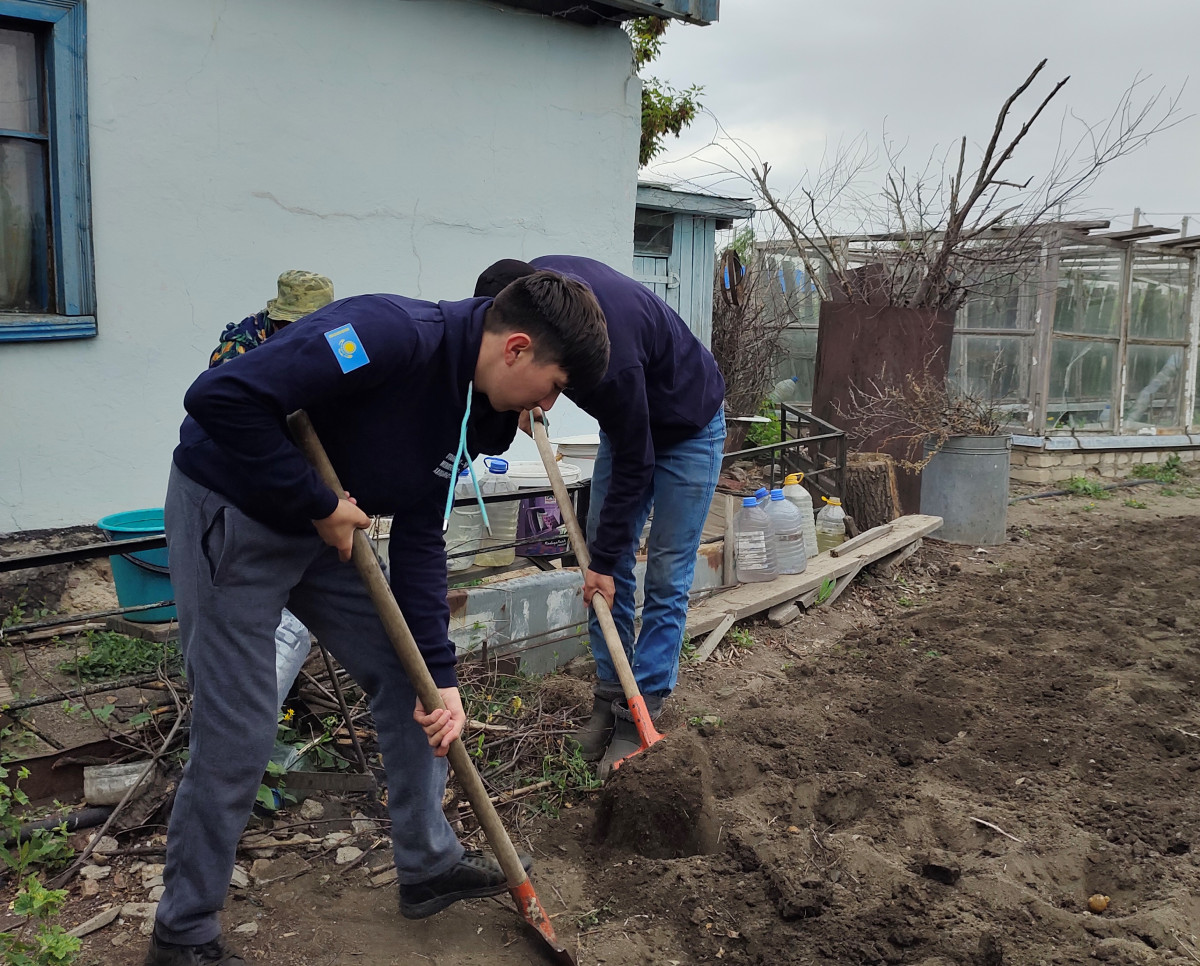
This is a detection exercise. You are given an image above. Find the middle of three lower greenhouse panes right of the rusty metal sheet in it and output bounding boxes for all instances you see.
[1046,338,1117,430]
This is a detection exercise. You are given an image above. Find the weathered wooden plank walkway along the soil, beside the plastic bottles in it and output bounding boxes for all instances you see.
[688,514,942,638]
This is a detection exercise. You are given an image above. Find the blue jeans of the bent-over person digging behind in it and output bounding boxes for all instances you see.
[588,410,725,697]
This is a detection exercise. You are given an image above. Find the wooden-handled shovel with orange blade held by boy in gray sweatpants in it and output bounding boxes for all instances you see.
[288,410,576,966]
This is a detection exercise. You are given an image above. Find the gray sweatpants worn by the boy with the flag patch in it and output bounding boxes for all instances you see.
[157,467,462,944]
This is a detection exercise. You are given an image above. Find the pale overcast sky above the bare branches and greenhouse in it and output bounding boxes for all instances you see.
[642,0,1200,234]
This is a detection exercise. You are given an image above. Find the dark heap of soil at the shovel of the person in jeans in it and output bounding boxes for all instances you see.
[596,731,718,858]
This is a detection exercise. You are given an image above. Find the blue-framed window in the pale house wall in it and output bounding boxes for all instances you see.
[0,0,96,342]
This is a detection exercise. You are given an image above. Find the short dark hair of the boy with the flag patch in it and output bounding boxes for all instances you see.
[476,270,608,394]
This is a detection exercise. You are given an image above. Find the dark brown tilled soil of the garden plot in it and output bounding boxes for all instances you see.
[35,500,1200,966]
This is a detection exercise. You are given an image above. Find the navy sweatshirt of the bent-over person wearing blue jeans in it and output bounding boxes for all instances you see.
[530,254,725,574]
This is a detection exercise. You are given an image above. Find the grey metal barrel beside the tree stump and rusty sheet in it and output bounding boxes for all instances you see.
[920,436,1013,547]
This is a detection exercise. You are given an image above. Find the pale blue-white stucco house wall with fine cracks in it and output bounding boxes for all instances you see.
[0,0,640,532]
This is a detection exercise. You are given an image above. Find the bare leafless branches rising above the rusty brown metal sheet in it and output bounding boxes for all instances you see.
[700,60,1186,311]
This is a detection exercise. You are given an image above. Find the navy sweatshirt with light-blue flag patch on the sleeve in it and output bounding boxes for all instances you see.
[174,295,496,688]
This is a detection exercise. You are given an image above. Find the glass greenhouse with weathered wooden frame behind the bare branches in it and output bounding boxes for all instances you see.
[757,221,1200,481]
